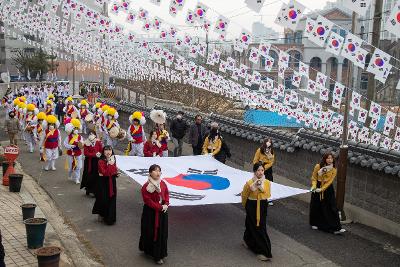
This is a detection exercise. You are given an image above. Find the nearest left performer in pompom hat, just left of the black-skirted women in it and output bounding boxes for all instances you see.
[64,119,83,184]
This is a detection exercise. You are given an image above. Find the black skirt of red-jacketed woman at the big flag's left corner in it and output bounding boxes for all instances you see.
[92,176,117,225]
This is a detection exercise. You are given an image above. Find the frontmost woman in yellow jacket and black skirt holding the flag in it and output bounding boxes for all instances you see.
[241,162,272,261]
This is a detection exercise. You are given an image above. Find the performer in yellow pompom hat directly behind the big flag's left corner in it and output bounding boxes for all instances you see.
[125,111,146,157]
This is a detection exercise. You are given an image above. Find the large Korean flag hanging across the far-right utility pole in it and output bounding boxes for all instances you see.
[367,48,392,83]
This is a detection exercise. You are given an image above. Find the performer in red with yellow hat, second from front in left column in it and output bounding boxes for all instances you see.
[40,115,61,171]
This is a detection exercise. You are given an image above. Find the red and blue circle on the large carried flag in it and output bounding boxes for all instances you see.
[163,174,230,190]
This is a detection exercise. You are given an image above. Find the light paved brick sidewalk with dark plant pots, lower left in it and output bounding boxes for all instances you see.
[0,157,101,267]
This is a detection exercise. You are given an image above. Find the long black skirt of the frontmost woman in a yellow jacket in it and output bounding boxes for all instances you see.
[243,199,272,258]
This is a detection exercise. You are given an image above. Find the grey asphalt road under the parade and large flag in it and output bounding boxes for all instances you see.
[2,112,400,266]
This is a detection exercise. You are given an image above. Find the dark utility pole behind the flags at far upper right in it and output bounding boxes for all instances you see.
[367,0,383,103]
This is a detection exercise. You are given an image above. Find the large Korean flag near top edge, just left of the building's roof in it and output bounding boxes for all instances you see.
[275,1,305,31]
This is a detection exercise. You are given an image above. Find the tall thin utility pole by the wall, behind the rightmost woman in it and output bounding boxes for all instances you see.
[336,11,357,221]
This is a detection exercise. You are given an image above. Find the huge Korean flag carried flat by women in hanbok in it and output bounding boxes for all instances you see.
[116,155,309,206]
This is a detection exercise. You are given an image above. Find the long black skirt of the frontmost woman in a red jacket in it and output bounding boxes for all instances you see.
[139,205,168,261]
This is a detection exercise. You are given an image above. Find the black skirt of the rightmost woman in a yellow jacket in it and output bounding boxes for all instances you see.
[310,182,342,233]
